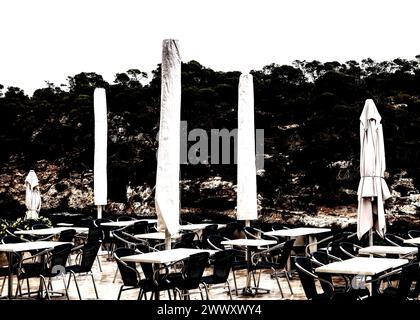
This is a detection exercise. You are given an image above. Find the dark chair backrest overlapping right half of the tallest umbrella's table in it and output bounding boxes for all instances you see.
[178,252,210,290]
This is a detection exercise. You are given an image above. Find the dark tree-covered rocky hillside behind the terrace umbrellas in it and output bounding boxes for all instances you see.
[0,59,420,227]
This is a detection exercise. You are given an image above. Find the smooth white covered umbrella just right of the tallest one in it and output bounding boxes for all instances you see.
[236,74,258,225]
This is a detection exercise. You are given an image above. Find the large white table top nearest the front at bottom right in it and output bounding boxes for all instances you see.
[315,257,408,276]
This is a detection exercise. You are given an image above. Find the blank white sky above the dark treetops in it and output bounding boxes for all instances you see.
[0,0,420,94]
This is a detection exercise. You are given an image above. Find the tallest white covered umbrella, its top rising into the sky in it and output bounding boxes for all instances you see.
[155,39,181,249]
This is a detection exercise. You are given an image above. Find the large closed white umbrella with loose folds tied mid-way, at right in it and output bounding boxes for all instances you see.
[357,99,391,245]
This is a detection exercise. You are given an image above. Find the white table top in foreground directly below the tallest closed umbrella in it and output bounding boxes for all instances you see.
[121,248,217,263]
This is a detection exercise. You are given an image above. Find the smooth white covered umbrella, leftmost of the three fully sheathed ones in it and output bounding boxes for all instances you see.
[93,88,108,219]
